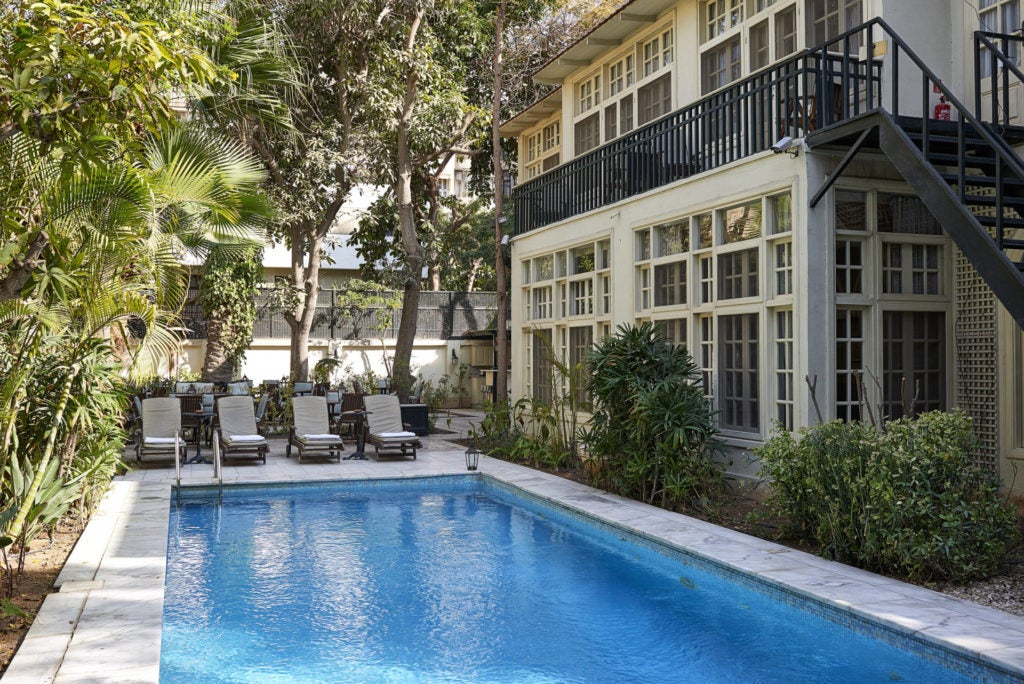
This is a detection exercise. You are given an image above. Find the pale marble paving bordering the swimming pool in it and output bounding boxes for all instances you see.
[2,421,1024,684]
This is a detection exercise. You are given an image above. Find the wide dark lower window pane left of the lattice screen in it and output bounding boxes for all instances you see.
[882,311,946,420]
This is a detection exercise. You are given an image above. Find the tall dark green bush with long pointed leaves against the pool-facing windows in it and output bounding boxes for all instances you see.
[586,323,725,509]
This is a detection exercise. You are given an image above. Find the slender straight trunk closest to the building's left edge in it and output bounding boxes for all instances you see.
[490,0,509,403]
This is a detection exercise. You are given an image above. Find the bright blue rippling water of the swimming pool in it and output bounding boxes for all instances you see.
[161,478,1003,684]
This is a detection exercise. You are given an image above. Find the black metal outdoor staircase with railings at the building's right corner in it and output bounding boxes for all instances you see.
[806,19,1024,328]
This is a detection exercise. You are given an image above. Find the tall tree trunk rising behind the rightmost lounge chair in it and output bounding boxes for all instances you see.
[391,7,424,401]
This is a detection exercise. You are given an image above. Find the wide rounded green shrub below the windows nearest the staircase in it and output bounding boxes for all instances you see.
[757,412,1018,582]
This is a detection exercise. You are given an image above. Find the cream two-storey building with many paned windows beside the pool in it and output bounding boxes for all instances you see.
[503,0,1024,491]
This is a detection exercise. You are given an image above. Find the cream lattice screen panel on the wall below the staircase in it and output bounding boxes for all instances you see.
[953,250,999,472]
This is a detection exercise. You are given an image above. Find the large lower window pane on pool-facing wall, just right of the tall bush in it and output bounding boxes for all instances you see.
[718,313,761,432]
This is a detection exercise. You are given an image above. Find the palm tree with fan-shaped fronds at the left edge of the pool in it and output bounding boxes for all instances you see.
[0,128,269,565]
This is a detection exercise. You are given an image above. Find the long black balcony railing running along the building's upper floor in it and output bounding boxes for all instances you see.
[514,23,883,234]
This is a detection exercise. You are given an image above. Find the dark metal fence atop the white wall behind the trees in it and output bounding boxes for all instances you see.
[181,285,498,340]
